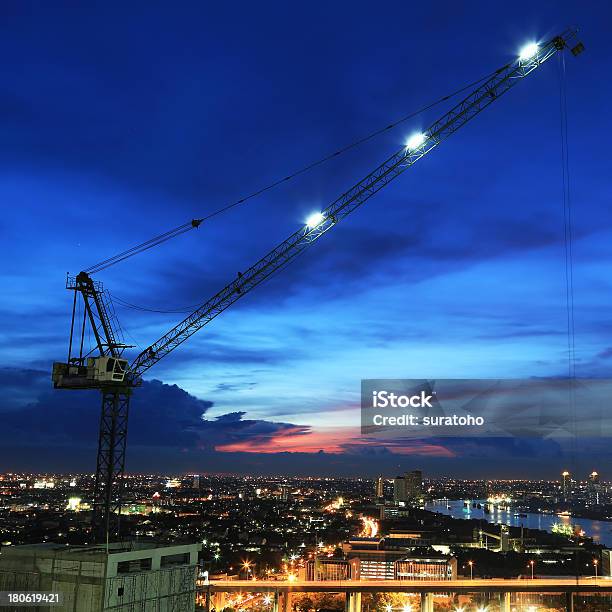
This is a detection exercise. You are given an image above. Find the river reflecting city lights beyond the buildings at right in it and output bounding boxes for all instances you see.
[425,500,612,548]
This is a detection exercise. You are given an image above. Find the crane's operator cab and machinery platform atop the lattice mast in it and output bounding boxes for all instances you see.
[52,357,128,389]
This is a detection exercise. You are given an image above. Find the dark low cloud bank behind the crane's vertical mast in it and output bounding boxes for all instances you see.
[0,368,308,451]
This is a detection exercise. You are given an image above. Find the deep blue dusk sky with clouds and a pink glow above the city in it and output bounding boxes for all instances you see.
[0,2,612,477]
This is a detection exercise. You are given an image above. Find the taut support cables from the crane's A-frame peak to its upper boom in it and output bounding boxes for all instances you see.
[84,69,516,274]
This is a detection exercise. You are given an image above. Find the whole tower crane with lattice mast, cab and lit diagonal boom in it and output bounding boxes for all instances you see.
[52,30,584,541]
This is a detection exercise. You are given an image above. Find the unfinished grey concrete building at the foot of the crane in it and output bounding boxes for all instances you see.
[0,542,201,612]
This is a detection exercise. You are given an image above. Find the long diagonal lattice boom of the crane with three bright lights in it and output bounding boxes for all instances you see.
[130,30,575,384]
